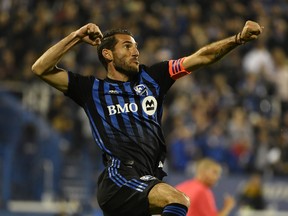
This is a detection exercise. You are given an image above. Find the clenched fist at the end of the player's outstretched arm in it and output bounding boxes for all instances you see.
[239,20,263,43]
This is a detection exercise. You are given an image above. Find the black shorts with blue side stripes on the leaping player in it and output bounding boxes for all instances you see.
[97,159,162,216]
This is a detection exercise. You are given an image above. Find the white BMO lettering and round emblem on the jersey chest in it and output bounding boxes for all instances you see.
[107,96,157,115]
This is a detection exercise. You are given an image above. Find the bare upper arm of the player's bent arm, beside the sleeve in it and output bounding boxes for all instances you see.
[39,66,69,93]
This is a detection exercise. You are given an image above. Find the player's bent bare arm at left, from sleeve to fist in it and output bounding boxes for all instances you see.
[32,23,102,92]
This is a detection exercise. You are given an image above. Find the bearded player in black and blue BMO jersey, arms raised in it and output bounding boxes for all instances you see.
[32,21,262,216]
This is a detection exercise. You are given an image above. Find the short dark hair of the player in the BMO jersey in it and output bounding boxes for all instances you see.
[97,29,133,69]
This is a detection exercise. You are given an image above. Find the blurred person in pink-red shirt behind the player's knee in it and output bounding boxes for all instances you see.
[176,158,235,216]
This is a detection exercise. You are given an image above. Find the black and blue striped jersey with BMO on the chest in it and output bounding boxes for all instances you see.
[66,59,189,175]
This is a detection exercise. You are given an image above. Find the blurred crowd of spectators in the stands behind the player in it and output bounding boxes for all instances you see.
[0,0,288,186]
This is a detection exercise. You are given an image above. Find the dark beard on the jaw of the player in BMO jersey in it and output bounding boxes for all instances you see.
[114,59,139,79]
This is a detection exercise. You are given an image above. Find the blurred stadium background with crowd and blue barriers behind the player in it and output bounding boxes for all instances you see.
[0,0,288,216]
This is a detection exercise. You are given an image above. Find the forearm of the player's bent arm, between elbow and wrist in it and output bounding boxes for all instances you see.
[32,32,80,76]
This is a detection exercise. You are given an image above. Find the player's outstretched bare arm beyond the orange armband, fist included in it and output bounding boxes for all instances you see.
[183,21,262,71]
